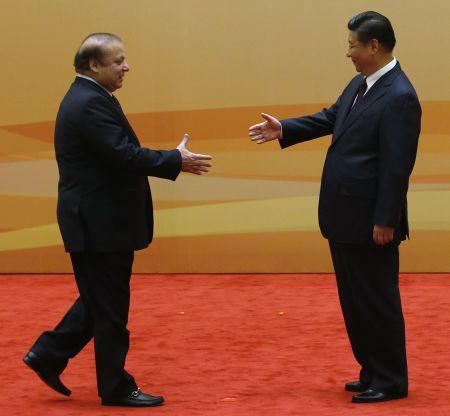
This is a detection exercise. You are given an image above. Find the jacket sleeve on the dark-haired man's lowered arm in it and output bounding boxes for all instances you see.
[374,93,422,228]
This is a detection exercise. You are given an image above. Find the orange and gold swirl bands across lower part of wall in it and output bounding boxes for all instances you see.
[0,102,450,272]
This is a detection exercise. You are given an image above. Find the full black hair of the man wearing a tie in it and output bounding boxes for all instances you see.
[347,12,395,52]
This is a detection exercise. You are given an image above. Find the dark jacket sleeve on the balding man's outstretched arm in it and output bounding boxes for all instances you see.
[79,96,181,180]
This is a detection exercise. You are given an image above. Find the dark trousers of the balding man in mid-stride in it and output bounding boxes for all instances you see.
[31,252,137,398]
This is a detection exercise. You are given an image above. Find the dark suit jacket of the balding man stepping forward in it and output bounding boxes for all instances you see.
[55,77,181,252]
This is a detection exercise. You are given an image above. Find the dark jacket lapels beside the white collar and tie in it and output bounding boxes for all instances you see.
[332,63,401,144]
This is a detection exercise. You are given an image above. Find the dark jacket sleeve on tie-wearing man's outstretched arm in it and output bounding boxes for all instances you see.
[279,97,340,149]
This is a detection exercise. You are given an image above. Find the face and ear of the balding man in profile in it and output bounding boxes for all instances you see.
[91,42,130,92]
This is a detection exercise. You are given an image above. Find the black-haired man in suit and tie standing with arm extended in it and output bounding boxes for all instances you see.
[249,12,421,403]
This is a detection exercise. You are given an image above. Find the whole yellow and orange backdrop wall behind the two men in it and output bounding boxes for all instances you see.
[0,0,450,272]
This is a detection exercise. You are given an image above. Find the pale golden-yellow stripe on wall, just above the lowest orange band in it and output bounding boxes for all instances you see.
[0,191,450,251]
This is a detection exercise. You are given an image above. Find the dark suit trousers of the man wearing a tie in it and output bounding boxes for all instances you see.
[329,240,408,392]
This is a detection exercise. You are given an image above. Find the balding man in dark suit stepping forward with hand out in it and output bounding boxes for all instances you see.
[24,33,211,407]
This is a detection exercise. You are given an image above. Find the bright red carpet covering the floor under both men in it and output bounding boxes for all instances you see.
[0,274,450,416]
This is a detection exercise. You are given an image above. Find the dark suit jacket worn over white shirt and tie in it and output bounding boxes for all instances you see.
[280,63,421,243]
